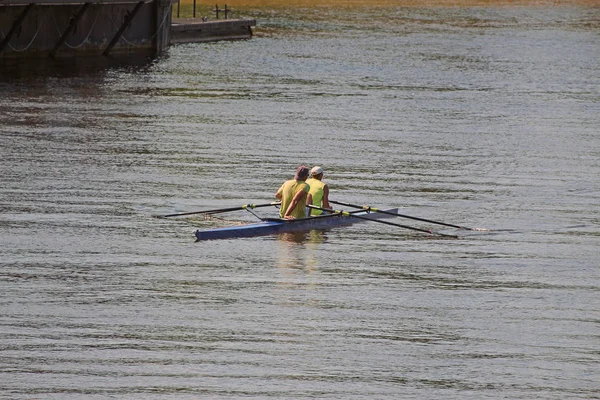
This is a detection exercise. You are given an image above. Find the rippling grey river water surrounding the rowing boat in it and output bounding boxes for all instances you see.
[0,5,600,399]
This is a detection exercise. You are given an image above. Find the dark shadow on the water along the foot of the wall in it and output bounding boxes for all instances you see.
[0,54,160,83]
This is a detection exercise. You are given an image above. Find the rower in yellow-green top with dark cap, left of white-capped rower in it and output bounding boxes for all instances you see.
[275,165,310,219]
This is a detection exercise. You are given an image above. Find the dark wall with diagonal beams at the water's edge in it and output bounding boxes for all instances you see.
[0,0,171,58]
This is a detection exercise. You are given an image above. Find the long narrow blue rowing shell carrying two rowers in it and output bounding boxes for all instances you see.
[195,208,398,242]
